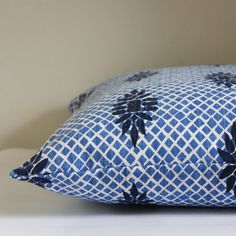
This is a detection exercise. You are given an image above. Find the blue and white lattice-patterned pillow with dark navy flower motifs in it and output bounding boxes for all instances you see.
[10,65,236,207]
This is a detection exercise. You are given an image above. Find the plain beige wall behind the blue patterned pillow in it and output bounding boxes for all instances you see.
[0,0,236,149]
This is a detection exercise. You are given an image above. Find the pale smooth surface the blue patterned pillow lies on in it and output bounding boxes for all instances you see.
[0,149,236,236]
